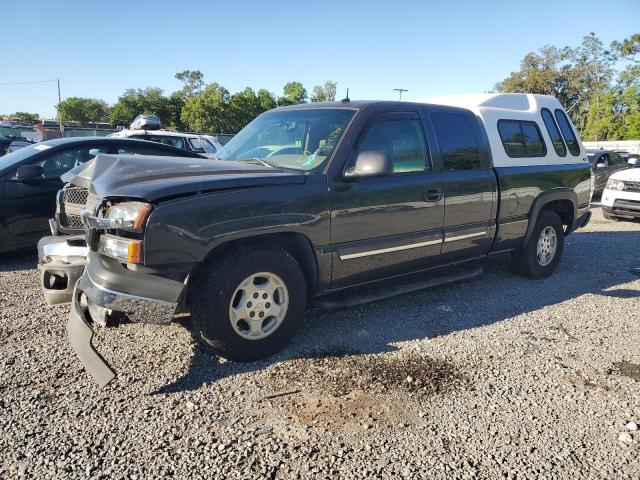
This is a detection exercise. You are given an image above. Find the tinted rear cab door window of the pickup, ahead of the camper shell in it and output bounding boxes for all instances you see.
[431,112,482,171]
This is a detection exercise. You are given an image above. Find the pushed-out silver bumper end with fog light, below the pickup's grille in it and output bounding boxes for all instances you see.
[38,235,89,305]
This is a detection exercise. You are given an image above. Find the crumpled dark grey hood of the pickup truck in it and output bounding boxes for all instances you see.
[60,155,306,202]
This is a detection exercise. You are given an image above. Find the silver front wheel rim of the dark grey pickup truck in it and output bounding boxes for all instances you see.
[229,272,289,340]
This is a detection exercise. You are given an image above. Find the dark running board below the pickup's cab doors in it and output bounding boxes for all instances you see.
[311,265,484,310]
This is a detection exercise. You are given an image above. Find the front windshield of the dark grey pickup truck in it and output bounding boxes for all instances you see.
[216,108,355,171]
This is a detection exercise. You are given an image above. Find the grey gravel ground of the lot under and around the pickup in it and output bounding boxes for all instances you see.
[0,210,640,479]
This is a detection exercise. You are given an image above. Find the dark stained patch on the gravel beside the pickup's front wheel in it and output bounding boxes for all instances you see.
[264,350,466,396]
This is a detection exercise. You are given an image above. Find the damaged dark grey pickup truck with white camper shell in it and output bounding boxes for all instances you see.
[49,94,593,385]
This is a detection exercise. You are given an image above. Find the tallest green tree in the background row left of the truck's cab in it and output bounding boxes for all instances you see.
[180,82,233,133]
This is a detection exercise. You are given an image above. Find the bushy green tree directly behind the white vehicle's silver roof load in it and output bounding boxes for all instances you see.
[109,87,172,126]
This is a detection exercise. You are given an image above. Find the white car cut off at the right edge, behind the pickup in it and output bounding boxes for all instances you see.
[602,167,640,220]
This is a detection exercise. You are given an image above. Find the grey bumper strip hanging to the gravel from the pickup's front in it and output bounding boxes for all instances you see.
[67,288,116,387]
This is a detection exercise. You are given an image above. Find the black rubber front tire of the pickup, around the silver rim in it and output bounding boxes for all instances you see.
[190,246,307,362]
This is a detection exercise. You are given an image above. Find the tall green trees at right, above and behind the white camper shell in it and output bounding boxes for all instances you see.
[495,33,640,140]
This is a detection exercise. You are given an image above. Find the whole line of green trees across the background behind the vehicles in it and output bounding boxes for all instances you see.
[3,33,640,140]
